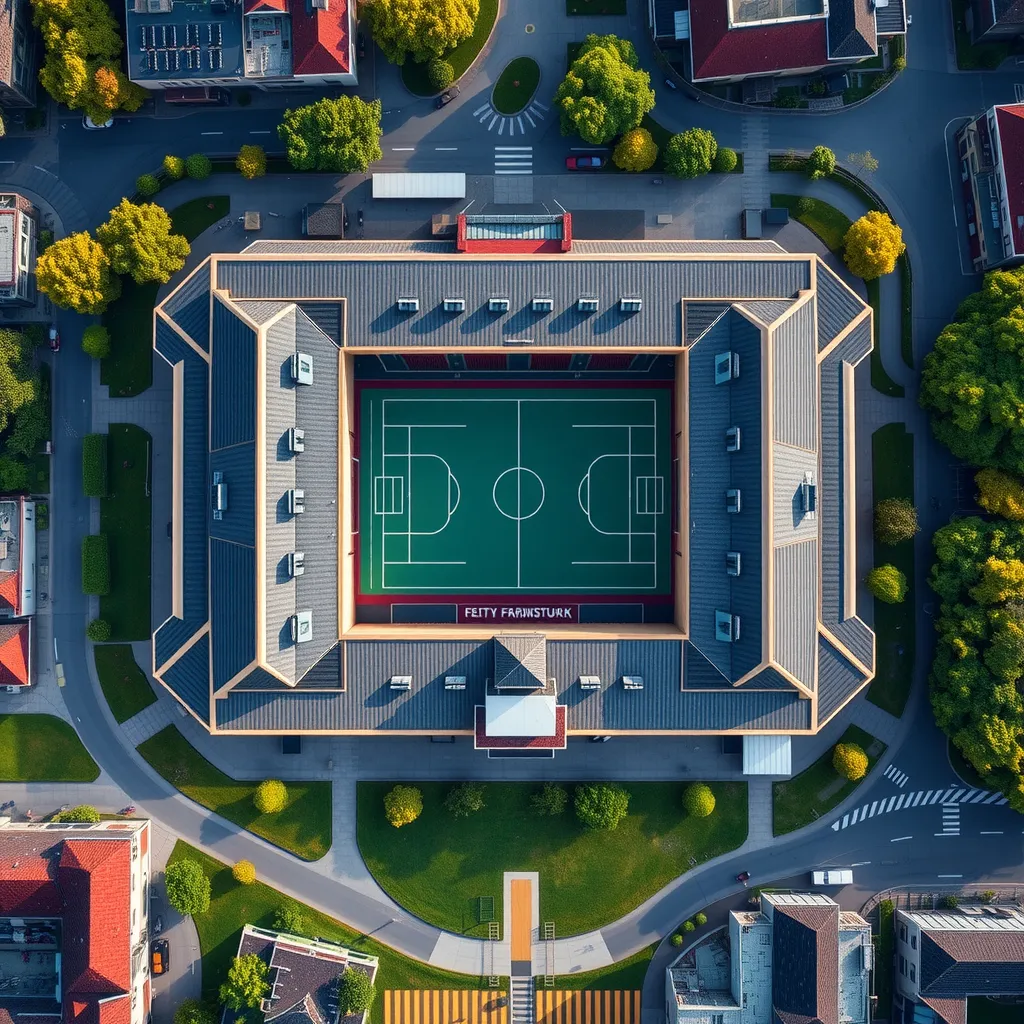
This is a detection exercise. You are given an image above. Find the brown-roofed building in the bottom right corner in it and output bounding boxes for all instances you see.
[892,905,1024,1024]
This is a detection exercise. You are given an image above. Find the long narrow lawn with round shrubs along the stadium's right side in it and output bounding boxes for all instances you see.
[867,423,916,718]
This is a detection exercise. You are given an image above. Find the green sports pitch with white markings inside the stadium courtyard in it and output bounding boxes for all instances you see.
[358,387,672,596]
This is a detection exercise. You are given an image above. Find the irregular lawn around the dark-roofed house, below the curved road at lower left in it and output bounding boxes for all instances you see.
[170,840,487,1024]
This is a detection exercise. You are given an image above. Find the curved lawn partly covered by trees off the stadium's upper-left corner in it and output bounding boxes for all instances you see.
[99,193,233,398]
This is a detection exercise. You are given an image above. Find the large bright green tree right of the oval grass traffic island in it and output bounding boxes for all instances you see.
[555,34,654,145]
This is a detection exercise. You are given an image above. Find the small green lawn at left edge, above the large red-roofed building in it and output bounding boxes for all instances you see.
[0,715,99,782]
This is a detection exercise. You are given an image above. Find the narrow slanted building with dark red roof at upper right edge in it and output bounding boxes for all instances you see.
[956,103,1024,271]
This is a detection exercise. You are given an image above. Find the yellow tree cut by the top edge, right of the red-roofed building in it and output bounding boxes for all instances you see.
[359,0,480,65]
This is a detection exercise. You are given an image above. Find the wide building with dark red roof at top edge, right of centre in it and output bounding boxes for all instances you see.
[648,0,907,82]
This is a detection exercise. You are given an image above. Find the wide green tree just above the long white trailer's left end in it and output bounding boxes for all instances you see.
[278,96,383,173]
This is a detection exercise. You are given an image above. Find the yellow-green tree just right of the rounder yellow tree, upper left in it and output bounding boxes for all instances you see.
[96,199,191,285]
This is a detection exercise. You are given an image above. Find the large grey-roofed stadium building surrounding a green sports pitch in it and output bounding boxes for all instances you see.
[154,226,874,774]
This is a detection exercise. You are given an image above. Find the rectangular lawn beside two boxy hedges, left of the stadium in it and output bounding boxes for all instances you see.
[99,423,153,640]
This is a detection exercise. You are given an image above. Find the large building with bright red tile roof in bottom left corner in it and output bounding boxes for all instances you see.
[0,818,152,1024]
